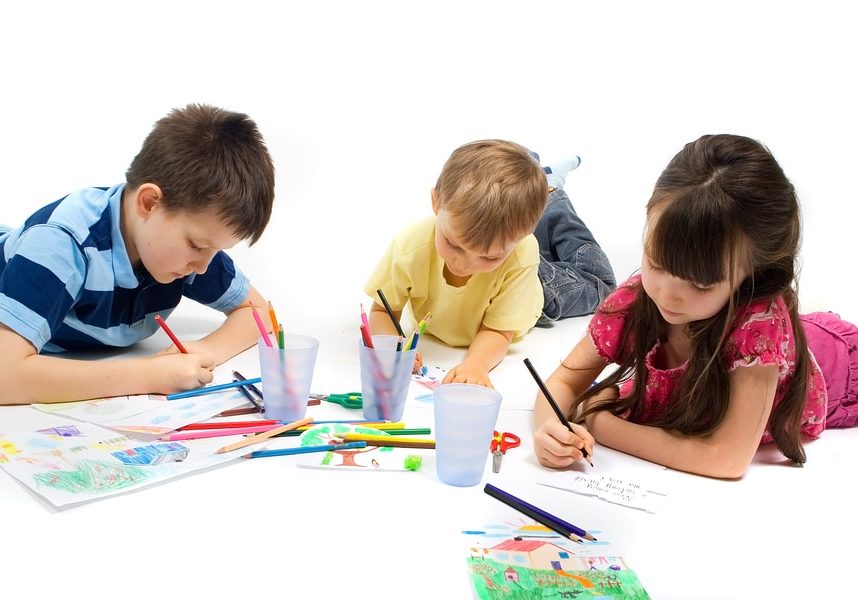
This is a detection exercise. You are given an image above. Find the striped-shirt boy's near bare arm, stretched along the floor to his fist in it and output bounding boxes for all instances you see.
[0,325,214,404]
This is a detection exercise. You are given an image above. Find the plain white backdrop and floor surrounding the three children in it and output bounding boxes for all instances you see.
[0,1,858,600]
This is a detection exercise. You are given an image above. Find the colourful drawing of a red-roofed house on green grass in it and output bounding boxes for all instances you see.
[463,519,649,600]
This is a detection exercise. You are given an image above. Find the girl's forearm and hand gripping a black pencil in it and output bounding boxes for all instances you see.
[533,337,608,469]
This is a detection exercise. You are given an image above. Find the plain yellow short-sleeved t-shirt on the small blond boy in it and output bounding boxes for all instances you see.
[364,217,543,346]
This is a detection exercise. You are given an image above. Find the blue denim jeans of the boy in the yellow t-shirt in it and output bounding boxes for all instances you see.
[534,186,617,325]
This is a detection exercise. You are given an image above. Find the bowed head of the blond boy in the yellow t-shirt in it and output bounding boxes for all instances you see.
[432,140,548,276]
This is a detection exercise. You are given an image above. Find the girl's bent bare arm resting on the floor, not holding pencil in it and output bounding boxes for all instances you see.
[587,366,778,479]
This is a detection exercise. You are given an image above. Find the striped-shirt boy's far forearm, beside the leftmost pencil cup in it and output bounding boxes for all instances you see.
[177,286,276,365]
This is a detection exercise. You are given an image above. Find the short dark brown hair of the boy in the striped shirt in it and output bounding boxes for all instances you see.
[125,104,274,244]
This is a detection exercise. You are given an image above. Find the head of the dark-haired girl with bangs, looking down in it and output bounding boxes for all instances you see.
[641,135,800,323]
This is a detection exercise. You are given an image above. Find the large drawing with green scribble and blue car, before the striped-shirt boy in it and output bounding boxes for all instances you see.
[0,422,247,506]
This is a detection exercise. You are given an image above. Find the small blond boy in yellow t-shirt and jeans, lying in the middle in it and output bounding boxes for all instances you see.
[364,140,613,387]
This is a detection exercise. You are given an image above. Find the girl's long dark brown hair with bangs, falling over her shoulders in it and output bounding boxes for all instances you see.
[577,135,809,463]
